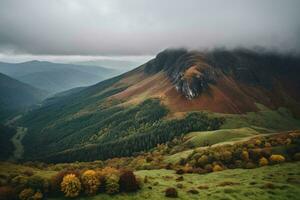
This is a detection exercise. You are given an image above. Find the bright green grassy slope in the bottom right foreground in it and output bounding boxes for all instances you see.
[47,162,300,200]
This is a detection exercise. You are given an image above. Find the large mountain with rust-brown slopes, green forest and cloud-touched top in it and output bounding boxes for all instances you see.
[19,49,300,162]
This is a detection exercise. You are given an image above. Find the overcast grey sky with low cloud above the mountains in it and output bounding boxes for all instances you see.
[0,0,300,60]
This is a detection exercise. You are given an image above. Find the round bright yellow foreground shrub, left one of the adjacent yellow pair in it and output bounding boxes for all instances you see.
[61,174,81,197]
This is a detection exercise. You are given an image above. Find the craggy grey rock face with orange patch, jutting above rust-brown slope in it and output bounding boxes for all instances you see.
[145,49,217,99]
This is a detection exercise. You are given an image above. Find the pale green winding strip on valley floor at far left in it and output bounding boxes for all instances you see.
[10,127,27,160]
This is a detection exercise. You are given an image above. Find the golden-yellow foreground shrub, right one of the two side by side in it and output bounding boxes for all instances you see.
[81,170,100,195]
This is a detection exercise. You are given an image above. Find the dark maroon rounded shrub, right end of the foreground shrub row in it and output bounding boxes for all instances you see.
[119,171,139,192]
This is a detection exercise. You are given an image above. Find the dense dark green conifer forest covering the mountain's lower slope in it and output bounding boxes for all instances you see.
[21,99,223,162]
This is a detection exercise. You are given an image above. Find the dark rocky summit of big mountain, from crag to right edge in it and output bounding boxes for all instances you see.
[144,49,300,99]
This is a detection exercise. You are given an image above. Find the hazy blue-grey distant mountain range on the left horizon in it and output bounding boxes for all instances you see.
[0,61,118,95]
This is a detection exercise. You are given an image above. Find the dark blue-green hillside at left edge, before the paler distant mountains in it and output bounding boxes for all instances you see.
[0,73,46,120]
